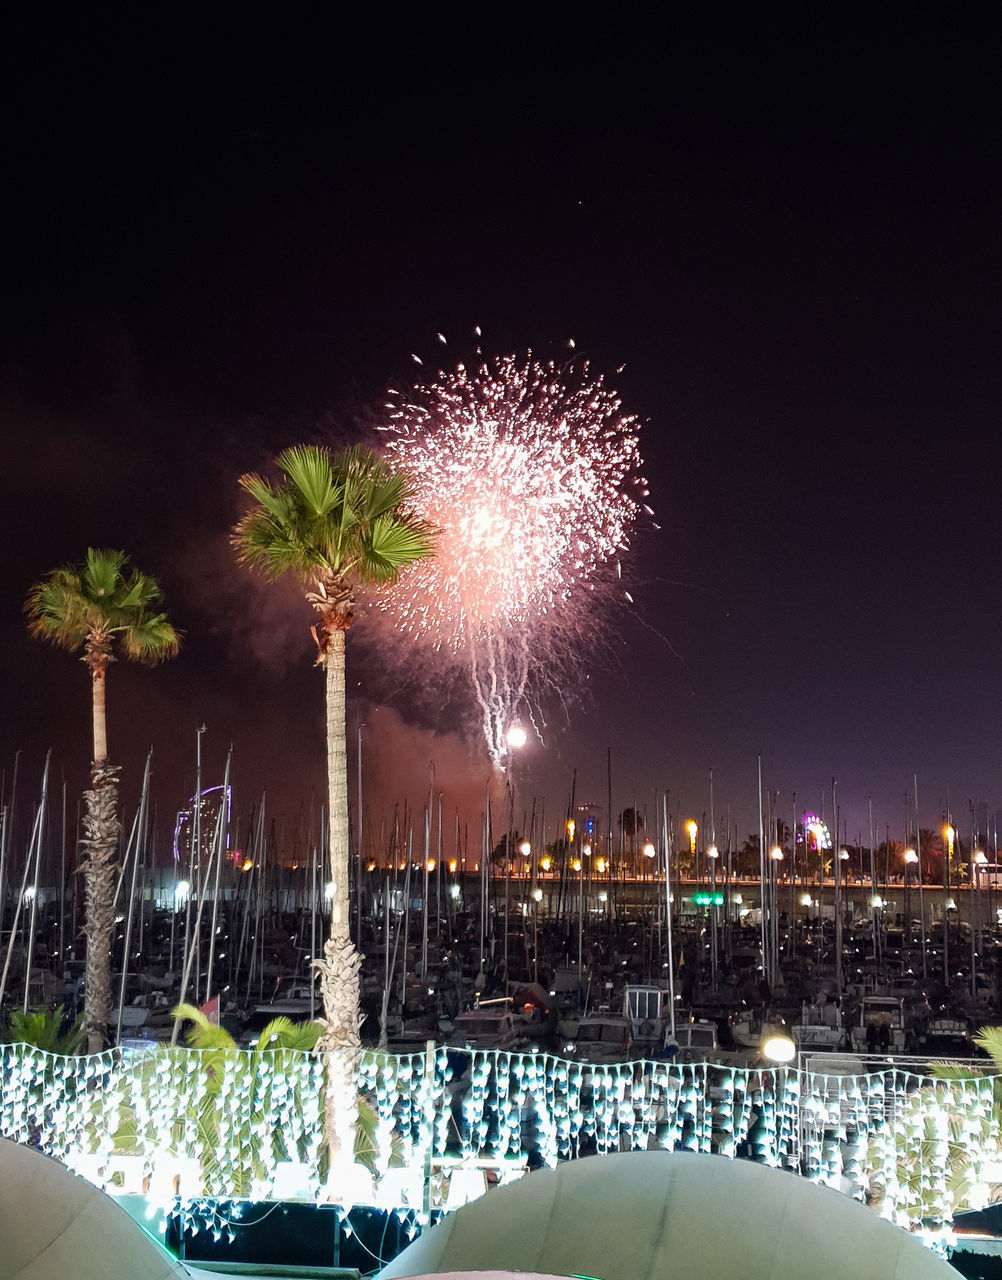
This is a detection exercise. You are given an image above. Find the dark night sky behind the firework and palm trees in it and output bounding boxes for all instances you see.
[0,17,1002,838]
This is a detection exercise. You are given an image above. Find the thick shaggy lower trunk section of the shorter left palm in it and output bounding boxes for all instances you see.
[81,760,120,1053]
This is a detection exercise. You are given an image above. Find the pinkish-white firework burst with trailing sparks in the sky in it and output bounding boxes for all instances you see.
[381,355,650,765]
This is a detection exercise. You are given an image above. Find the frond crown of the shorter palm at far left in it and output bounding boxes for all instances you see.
[24,547,180,666]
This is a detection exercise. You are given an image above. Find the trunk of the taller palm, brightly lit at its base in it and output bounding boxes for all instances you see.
[317,618,362,1184]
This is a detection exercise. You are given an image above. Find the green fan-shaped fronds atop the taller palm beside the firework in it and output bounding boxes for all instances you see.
[233,444,434,585]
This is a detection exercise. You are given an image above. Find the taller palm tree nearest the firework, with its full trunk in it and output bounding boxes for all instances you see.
[233,445,434,1169]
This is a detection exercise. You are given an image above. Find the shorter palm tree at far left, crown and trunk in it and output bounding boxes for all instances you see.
[24,547,179,1053]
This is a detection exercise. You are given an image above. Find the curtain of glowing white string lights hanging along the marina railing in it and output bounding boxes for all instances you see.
[0,1044,1002,1225]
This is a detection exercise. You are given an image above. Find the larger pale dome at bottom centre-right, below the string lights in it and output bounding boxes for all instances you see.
[379,1151,956,1280]
